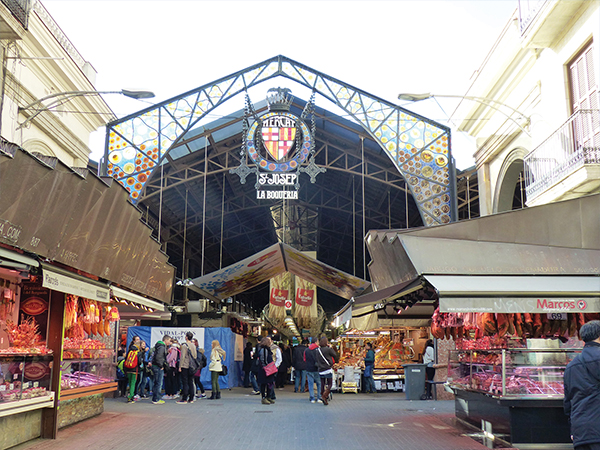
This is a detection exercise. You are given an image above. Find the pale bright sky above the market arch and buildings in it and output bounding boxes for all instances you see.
[42,0,518,169]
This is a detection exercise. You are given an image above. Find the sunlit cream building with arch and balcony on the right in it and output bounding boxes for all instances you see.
[453,0,600,215]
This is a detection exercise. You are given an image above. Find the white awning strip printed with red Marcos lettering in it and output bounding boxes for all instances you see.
[440,297,600,314]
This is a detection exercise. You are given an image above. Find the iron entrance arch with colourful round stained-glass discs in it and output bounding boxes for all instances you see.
[102,56,456,226]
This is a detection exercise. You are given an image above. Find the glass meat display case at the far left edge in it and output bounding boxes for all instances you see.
[0,353,53,406]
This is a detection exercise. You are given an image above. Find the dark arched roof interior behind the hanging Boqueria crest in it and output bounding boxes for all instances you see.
[138,99,422,313]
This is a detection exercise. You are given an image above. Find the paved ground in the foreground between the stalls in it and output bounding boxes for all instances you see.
[15,386,508,450]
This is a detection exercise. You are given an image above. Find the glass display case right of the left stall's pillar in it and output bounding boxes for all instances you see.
[60,349,116,390]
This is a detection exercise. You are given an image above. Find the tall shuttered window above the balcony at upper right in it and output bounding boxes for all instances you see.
[568,43,600,149]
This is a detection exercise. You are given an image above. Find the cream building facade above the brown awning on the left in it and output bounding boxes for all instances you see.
[0,0,115,167]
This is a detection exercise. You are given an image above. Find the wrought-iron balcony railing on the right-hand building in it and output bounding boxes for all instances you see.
[524,109,600,200]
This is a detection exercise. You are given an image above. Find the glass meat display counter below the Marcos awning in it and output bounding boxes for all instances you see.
[448,349,581,399]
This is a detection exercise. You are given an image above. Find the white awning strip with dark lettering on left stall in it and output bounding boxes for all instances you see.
[42,264,110,303]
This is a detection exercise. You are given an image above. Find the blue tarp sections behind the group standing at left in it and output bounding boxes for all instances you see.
[127,327,242,390]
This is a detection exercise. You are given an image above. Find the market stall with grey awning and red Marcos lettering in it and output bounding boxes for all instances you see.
[360,195,600,448]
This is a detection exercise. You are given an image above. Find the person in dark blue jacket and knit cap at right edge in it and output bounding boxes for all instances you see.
[564,320,600,450]
